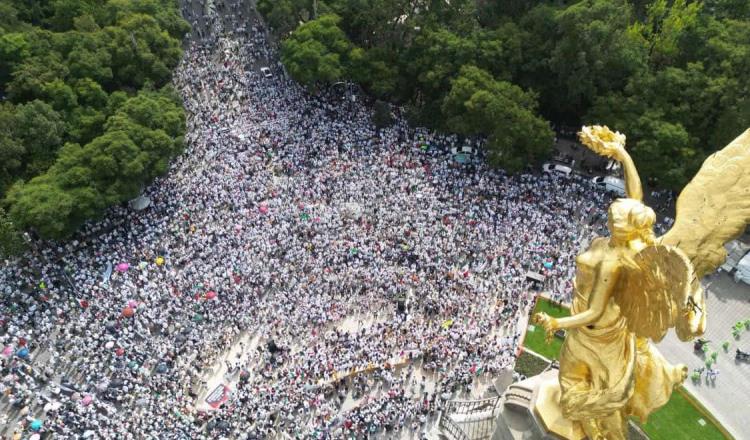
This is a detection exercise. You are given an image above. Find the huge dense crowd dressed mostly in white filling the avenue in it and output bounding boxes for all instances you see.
[0,1,636,439]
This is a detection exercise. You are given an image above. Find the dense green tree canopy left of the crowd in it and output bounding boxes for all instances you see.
[0,0,189,249]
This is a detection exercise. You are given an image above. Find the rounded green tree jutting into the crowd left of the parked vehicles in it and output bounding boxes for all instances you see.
[442,66,554,172]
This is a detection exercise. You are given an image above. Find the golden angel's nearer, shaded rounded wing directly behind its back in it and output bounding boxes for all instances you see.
[614,244,694,342]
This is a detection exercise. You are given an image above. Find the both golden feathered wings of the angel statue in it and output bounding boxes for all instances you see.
[614,130,750,342]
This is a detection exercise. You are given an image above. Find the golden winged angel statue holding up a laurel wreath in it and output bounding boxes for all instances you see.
[534,126,750,440]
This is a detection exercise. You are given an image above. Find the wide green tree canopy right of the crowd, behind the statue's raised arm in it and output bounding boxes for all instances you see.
[264,0,750,190]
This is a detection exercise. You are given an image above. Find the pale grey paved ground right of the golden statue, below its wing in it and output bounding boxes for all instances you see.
[658,273,750,439]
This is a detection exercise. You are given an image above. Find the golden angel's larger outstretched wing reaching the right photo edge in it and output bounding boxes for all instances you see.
[658,130,750,280]
